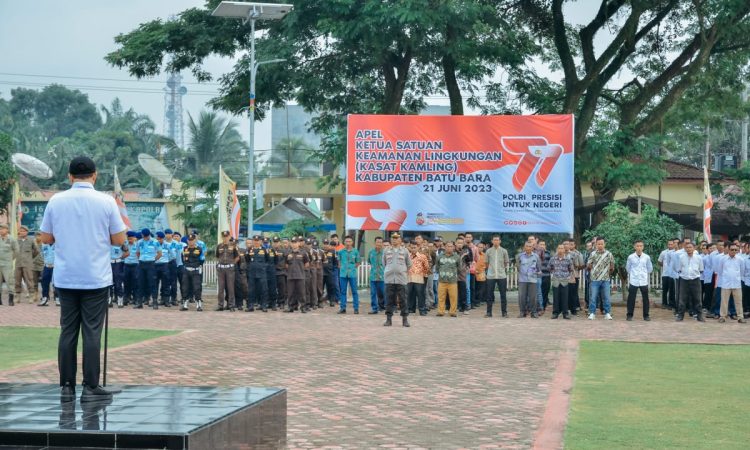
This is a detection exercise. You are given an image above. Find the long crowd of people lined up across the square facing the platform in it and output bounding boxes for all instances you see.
[0,225,750,326]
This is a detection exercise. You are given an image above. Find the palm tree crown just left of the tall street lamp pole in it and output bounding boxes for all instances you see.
[187,111,247,177]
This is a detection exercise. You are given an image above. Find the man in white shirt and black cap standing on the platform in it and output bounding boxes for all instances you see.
[41,156,126,403]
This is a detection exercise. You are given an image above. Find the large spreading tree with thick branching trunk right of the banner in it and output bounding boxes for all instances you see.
[508,0,750,225]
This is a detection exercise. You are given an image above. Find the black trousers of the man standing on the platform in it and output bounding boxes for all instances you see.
[57,287,109,387]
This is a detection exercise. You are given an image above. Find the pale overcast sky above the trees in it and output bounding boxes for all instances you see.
[0,0,595,154]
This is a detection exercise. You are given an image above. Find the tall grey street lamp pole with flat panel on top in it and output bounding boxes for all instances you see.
[211,1,293,236]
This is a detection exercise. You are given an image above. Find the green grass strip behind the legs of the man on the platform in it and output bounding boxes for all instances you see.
[0,327,177,370]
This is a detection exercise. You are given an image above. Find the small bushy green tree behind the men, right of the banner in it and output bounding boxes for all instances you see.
[584,202,681,299]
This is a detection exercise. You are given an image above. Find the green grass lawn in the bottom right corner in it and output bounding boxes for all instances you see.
[565,341,750,450]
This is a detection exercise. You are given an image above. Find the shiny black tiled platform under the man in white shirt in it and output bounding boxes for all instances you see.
[0,383,286,450]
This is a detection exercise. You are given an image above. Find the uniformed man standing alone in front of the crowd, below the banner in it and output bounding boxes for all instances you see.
[383,233,412,327]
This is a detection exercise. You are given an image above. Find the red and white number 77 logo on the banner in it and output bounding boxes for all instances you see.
[500,136,564,192]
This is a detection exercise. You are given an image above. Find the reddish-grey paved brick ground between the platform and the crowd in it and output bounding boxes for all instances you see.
[0,296,750,449]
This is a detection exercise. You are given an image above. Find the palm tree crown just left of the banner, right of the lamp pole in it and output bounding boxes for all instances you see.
[265,138,321,178]
